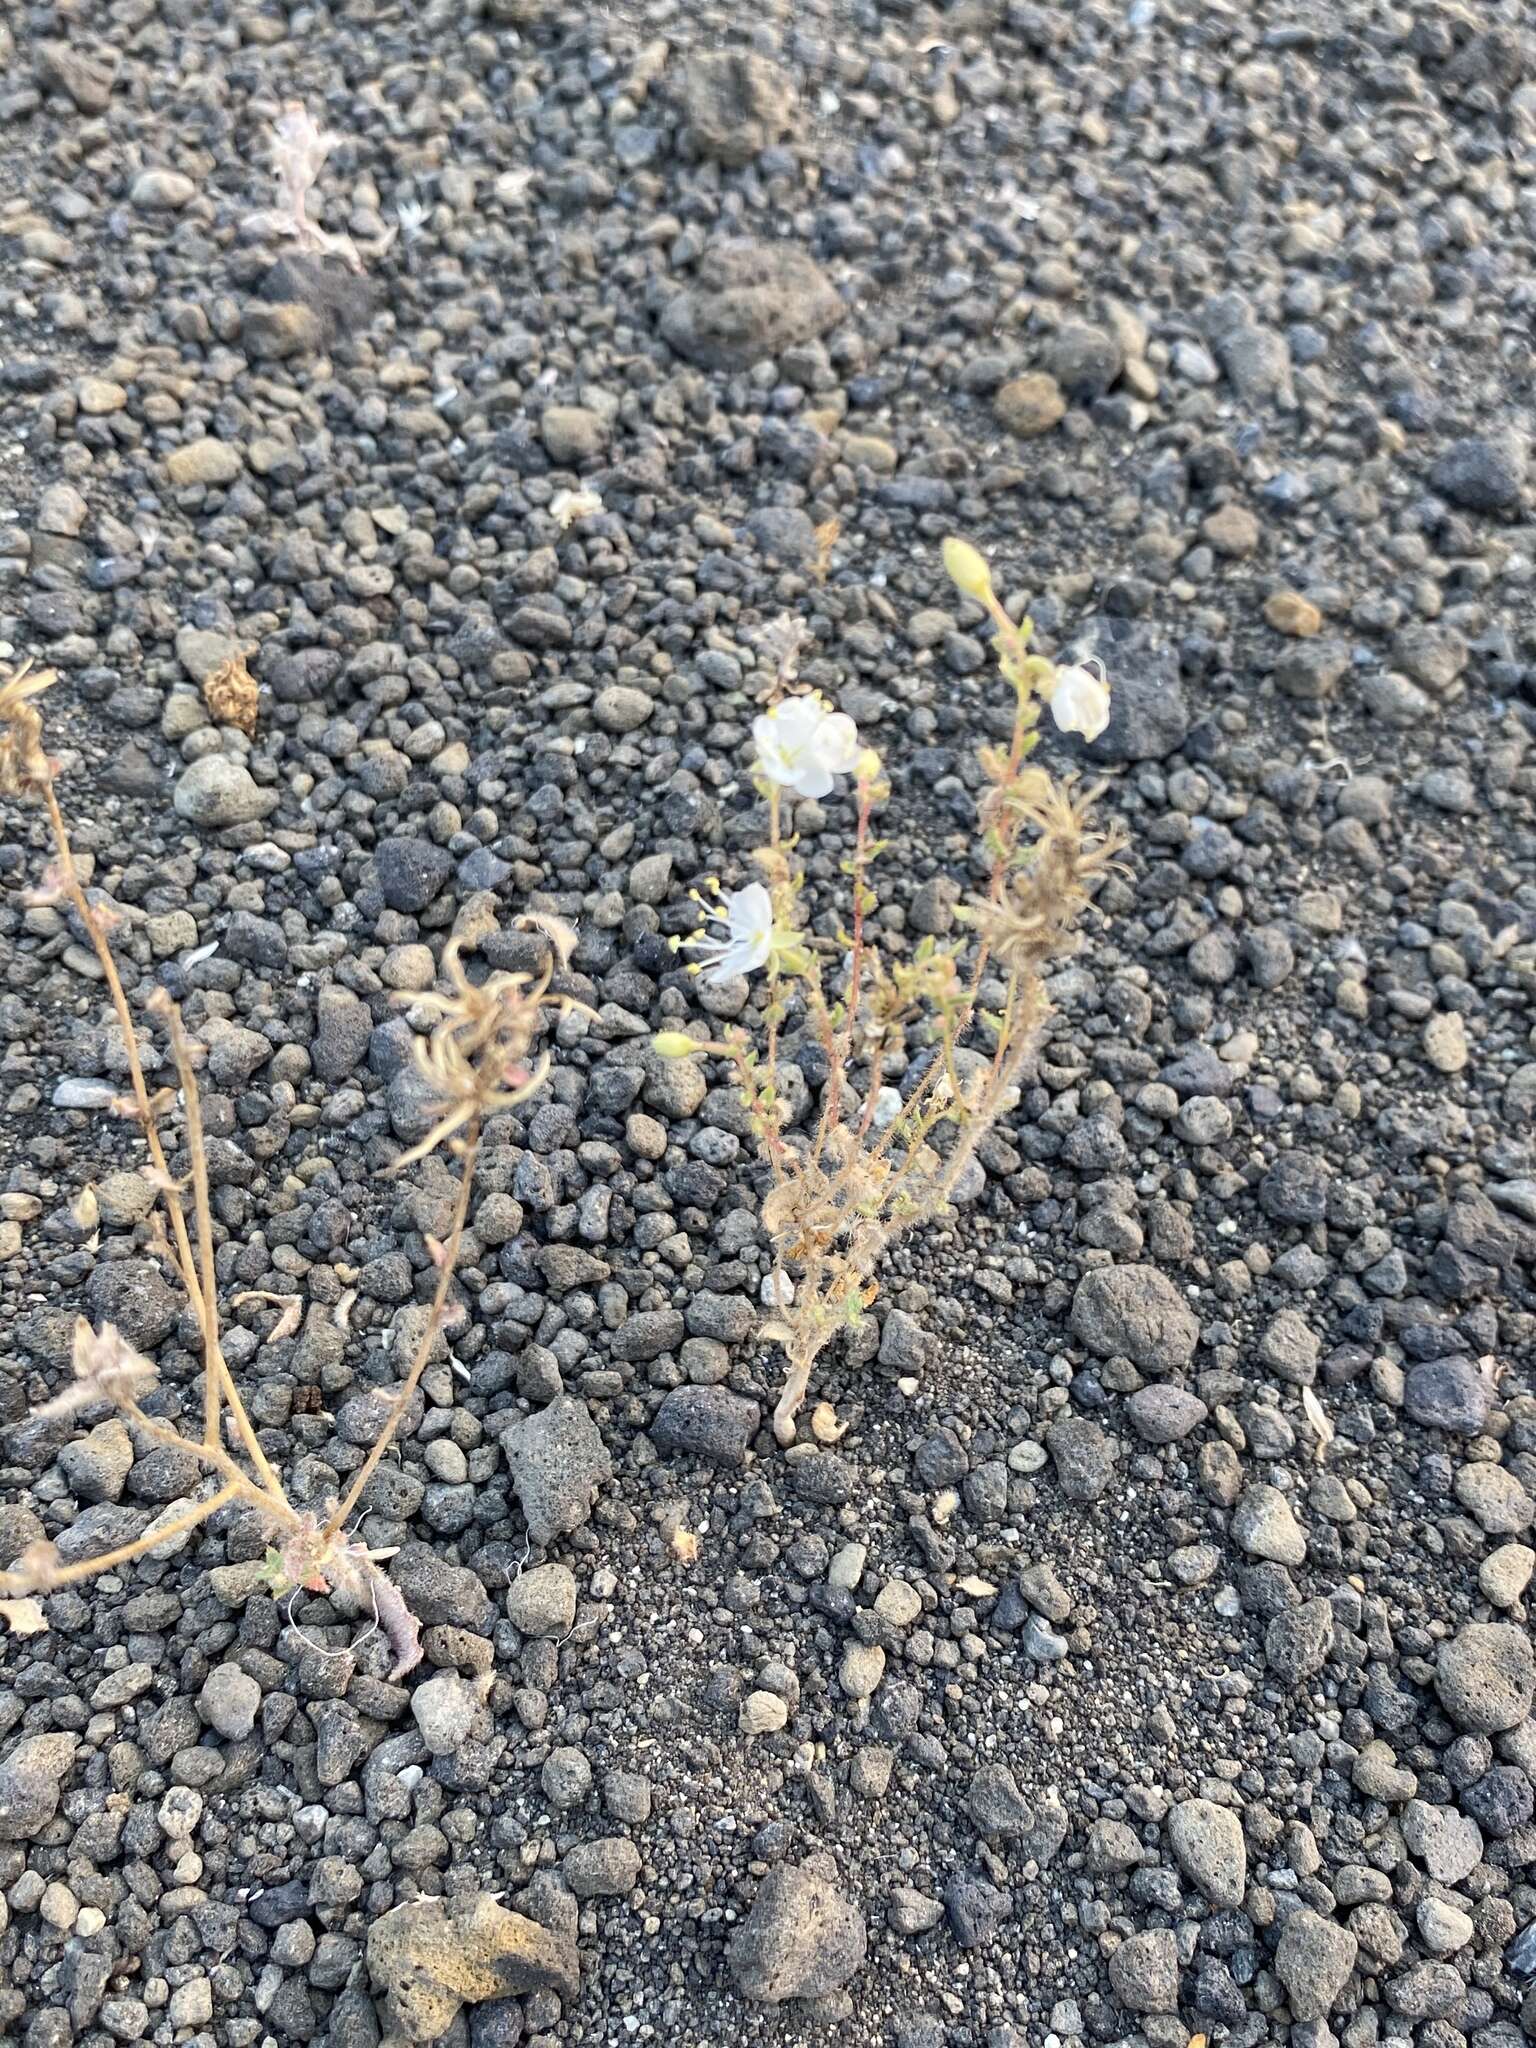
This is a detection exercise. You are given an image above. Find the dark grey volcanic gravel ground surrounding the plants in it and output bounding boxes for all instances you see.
[0,0,1536,2048]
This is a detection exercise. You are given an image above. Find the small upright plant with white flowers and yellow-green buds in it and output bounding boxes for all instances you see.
[655,541,1122,1444]
